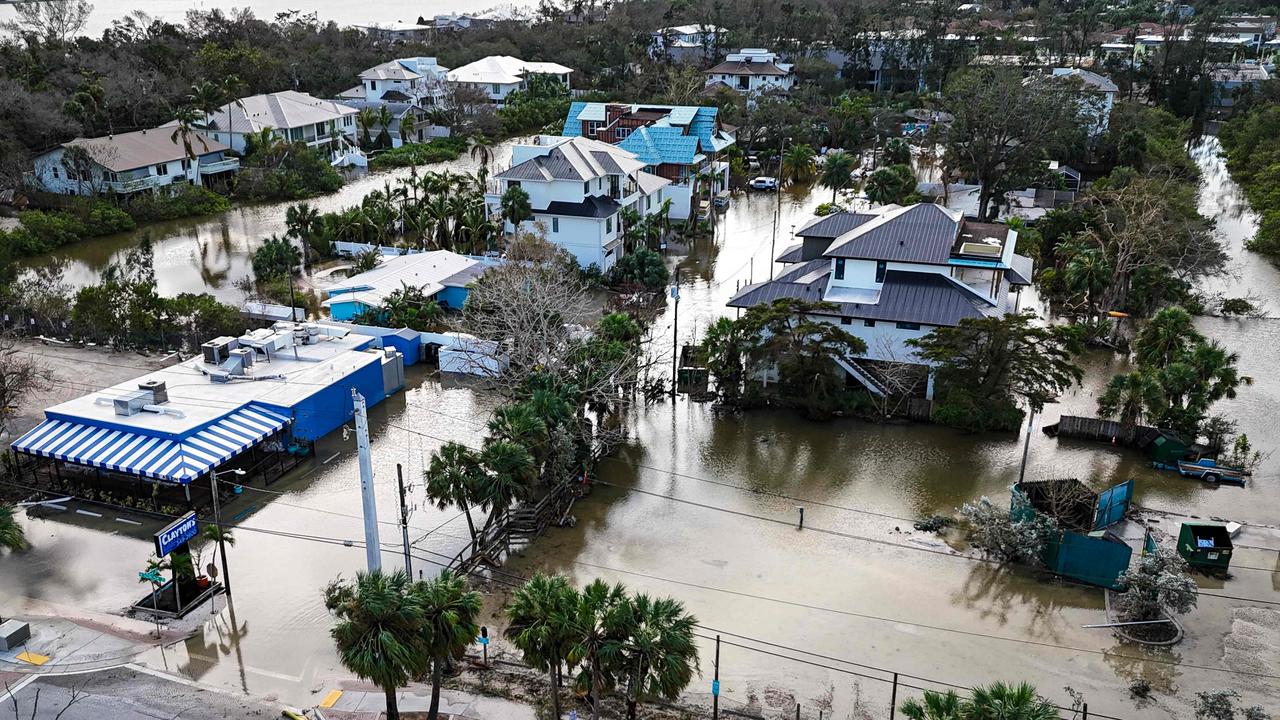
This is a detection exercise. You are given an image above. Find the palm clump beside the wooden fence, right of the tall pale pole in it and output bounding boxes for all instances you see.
[424,374,590,551]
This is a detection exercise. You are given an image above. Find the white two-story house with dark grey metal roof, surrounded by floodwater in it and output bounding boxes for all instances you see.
[728,204,1032,397]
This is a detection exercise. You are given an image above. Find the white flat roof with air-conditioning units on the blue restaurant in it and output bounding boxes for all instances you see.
[45,333,381,436]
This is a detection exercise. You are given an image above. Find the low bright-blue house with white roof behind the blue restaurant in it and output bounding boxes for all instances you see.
[321,250,492,320]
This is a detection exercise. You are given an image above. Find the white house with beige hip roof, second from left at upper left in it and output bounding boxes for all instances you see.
[186,90,356,152]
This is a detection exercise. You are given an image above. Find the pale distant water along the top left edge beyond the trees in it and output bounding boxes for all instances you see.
[0,0,538,37]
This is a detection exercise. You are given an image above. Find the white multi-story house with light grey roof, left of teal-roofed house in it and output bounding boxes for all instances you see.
[485,135,671,272]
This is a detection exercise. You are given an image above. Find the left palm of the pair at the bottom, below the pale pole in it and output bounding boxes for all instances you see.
[324,570,434,720]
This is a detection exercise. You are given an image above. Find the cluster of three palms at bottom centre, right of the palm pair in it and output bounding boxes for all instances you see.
[504,574,699,720]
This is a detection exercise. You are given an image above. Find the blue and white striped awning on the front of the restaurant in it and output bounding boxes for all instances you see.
[13,406,289,484]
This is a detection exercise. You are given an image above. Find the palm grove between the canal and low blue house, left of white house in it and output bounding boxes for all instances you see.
[285,170,502,255]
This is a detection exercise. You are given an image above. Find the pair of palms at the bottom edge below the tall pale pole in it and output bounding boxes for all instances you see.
[324,570,481,720]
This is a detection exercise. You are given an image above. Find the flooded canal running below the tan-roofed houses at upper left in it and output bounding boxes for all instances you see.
[13,141,515,305]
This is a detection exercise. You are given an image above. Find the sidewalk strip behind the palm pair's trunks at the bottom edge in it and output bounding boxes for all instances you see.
[320,685,538,720]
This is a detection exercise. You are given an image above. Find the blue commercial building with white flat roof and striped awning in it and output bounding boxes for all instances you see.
[12,323,404,486]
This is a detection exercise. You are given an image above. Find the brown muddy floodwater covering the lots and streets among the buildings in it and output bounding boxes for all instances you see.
[0,138,1280,719]
